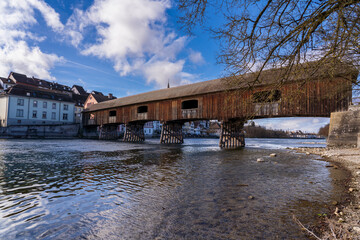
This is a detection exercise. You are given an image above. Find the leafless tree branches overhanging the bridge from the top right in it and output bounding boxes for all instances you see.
[178,0,360,90]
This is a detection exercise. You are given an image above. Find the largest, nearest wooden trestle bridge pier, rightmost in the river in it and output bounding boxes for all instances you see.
[219,121,245,148]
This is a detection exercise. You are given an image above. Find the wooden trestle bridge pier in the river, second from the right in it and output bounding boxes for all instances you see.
[160,122,184,144]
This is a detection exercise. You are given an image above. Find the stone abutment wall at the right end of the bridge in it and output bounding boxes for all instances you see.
[327,106,360,147]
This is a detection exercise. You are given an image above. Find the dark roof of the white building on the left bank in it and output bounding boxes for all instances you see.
[2,84,73,102]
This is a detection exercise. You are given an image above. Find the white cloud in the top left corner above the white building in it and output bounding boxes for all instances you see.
[0,0,64,79]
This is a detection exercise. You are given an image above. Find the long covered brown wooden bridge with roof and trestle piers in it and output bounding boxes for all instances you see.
[83,62,358,148]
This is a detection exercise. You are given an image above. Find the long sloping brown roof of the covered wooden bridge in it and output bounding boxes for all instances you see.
[84,61,358,111]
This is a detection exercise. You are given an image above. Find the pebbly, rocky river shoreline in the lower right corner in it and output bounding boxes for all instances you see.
[294,148,360,240]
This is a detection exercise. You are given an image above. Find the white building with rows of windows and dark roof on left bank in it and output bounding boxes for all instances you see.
[0,84,75,127]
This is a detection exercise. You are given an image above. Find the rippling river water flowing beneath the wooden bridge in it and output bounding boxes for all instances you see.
[0,139,346,239]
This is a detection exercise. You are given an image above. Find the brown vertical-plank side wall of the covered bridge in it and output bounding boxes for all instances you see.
[84,78,351,125]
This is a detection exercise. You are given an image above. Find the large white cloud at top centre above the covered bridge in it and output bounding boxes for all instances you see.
[70,0,193,87]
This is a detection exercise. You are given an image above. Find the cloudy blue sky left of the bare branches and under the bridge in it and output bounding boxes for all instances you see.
[0,0,329,131]
